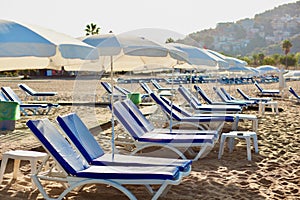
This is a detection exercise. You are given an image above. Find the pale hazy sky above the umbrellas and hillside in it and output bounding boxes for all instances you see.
[0,0,297,39]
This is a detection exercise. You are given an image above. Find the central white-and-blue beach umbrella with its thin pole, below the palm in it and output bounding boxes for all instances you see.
[82,34,188,159]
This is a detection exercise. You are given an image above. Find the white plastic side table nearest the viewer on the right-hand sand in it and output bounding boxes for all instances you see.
[218,131,258,161]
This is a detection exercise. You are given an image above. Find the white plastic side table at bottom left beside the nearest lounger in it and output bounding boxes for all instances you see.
[0,150,47,189]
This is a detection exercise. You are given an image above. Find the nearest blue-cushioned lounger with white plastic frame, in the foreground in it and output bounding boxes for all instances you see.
[27,119,188,199]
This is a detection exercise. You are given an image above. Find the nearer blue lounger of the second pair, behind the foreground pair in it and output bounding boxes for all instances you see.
[113,101,216,160]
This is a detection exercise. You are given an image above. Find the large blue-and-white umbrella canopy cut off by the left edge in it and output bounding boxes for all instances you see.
[0,20,98,71]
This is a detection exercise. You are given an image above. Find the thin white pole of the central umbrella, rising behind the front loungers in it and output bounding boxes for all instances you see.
[110,56,115,161]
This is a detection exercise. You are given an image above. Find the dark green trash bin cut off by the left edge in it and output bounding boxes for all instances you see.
[0,101,20,131]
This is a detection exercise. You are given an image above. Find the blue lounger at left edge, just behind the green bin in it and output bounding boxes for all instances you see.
[1,87,59,115]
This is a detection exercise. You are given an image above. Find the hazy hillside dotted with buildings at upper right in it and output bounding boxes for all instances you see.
[179,1,300,56]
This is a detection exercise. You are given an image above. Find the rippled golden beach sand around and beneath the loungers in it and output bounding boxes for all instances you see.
[0,78,300,199]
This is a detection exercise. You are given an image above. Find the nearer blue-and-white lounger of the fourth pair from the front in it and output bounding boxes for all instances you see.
[178,86,242,113]
